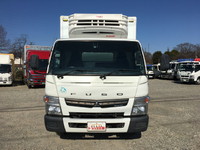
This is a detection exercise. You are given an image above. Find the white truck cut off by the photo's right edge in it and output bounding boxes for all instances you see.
[179,61,200,84]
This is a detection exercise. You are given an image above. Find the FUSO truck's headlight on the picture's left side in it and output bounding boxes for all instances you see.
[44,96,62,115]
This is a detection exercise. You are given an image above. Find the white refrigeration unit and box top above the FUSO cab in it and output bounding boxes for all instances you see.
[60,14,136,39]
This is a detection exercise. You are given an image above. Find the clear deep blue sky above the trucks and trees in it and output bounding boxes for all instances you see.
[0,0,200,53]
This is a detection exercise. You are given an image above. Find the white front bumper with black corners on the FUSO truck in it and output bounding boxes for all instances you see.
[44,115,149,133]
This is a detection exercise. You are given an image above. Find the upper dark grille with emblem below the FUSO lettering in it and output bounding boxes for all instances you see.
[65,99,128,108]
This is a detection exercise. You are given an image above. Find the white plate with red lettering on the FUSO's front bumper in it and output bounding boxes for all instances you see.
[87,122,106,132]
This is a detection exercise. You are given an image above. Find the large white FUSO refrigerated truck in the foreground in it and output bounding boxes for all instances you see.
[44,14,149,134]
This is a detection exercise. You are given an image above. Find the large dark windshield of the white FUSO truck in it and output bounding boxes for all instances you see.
[48,41,145,76]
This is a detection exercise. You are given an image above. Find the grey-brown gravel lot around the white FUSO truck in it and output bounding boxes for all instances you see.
[0,79,200,150]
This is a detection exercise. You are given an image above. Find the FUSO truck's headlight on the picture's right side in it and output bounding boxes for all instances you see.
[132,96,150,115]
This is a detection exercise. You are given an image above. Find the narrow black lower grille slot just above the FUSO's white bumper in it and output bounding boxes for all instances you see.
[69,112,124,119]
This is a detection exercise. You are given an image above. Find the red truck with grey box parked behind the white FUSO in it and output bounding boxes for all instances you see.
[24,45,51,88]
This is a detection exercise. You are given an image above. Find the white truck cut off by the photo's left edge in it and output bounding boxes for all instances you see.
[0,53,14,85]
